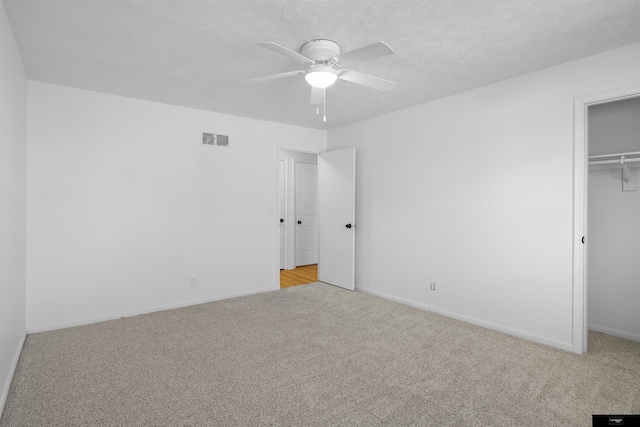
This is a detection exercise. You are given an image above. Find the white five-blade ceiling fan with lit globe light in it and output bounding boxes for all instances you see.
[244,39,396,105]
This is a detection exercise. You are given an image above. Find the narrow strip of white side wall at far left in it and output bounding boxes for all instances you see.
[0,2,27,416]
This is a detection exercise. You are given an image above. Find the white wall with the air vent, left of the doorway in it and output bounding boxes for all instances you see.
[27,81,326,331]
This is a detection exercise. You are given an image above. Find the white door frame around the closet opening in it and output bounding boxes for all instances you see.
[572,85,640,354]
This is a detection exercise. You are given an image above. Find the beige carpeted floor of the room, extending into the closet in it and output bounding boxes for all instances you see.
[0,283,640,427]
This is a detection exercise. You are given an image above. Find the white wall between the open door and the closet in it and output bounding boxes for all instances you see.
[327,44,640,350]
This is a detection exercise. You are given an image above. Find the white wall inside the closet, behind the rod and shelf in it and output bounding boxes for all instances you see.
[587,98,640,341]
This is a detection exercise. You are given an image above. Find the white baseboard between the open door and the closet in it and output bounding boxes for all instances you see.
[356,286,573,352]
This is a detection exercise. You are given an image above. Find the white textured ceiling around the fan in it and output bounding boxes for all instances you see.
[3,0,640,129]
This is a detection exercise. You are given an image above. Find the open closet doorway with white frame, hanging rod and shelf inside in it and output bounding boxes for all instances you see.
[573,85,640,353]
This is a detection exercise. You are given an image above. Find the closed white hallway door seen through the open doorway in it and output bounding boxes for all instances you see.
[296,162,318,266]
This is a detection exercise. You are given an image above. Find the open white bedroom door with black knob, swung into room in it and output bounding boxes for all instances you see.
[318,148,356,290]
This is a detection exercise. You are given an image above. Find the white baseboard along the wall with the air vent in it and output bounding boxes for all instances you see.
[27,288,279,334]
